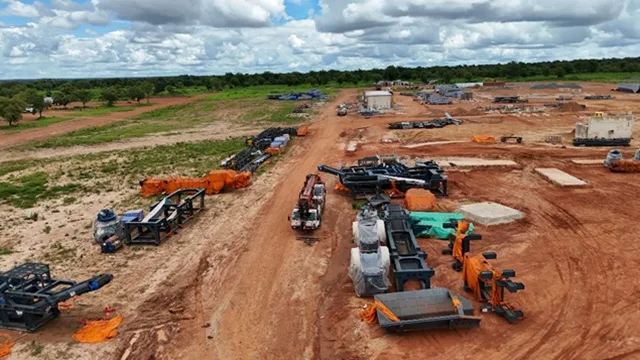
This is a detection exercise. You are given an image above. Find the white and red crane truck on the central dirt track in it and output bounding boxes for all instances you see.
[289,174,326,230]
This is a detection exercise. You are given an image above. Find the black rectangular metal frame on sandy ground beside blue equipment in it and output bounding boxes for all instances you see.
[123,189,205,245]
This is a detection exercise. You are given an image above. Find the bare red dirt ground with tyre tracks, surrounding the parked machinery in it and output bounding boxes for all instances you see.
[107,84,640,359]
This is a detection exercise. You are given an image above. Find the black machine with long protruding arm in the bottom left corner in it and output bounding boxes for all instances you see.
[0,263,113,332]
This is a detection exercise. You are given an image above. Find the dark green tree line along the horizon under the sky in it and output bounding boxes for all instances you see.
[0,58,640,126]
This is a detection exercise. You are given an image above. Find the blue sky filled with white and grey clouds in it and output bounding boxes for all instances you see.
[0,0,640,79]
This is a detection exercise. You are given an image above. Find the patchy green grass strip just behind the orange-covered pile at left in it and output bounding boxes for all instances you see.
[0,139,245,208]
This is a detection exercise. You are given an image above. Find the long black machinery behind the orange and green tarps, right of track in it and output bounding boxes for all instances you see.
[318,156,447,198]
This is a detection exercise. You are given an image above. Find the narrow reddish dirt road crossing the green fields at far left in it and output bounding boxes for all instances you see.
[0,94,207,150]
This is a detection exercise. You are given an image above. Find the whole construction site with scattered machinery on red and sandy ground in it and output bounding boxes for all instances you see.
[0,81,640,360]
